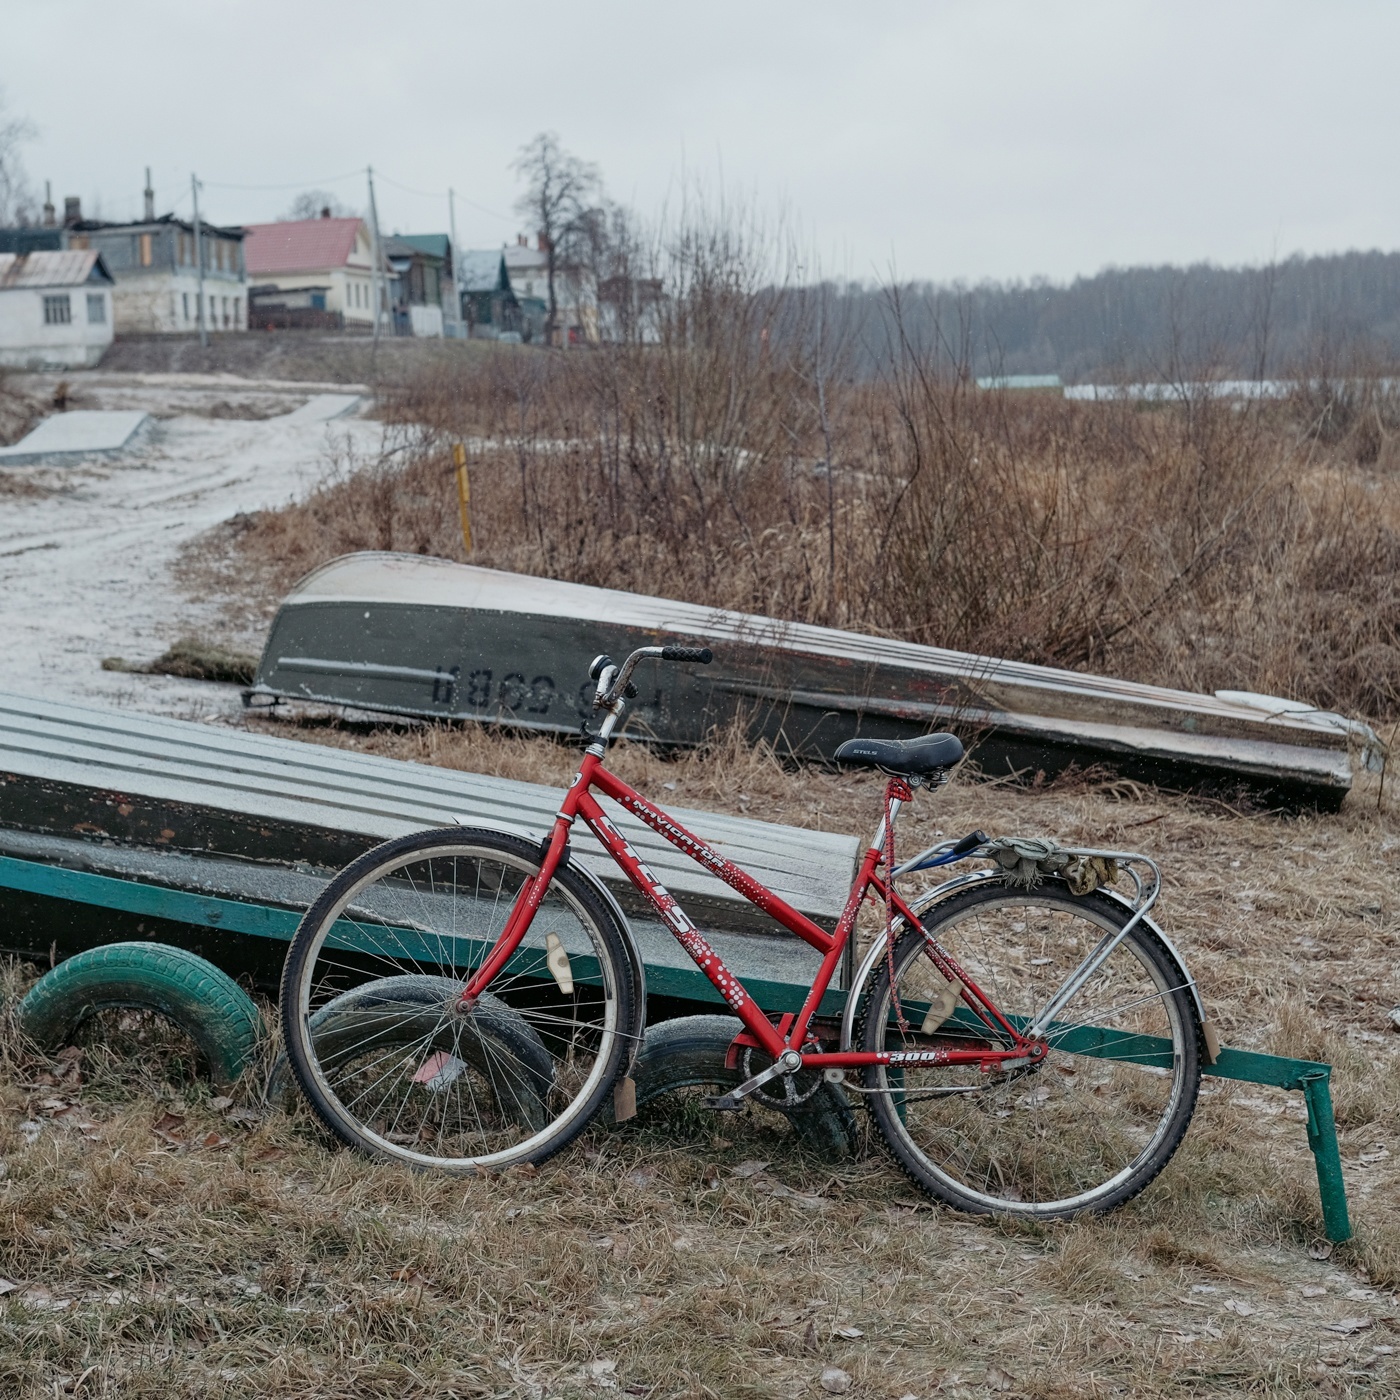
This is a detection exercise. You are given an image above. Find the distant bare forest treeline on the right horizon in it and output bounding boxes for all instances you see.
[827,252,1400,384]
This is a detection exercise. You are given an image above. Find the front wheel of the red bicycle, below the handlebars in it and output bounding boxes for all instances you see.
[281,827,636,1172]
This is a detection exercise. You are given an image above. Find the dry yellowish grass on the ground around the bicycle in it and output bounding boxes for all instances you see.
[0,725,1400,1400]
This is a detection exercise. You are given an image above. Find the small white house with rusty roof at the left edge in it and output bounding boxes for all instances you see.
[0,249,115,370]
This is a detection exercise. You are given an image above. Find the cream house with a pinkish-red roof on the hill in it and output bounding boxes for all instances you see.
[244,211,374,329]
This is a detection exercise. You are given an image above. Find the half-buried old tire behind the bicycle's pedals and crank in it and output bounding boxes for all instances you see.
[631,1016,858,1161]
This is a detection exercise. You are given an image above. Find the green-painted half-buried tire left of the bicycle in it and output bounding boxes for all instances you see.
[15,944,263,1085]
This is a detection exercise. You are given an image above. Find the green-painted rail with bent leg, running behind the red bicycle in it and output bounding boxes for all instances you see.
[0,855,1352,1242]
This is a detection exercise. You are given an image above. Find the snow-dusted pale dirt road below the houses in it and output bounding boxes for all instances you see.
[0,374,381,718]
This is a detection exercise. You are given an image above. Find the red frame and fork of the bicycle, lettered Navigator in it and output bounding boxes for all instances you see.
[462,745,1047,1072]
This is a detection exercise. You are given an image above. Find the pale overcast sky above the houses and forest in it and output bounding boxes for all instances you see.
[0,0,1400,281]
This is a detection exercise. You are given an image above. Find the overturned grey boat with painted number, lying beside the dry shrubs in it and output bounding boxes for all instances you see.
[245,553,1379,809]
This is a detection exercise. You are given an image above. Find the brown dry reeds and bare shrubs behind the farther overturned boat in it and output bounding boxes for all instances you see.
[215,230,1400,718]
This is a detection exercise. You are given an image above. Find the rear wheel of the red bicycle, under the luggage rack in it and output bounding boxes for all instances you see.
[860,881,1201,1219]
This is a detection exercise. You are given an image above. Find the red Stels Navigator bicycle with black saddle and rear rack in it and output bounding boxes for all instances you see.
[281,647,1204,1218]
